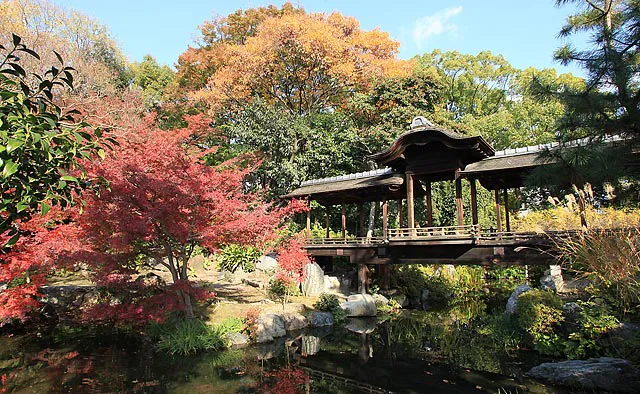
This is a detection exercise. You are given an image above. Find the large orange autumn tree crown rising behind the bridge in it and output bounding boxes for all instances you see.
[183,8,410,115]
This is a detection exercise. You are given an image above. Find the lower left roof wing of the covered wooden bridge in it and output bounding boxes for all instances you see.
[282,168,406,205]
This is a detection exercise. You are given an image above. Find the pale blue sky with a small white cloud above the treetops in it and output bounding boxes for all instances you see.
[54,0,581,74]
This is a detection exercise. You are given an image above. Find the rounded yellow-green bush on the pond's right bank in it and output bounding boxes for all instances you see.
[518,290,566,356]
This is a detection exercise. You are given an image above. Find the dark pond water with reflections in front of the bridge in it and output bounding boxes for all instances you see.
[0,305,564,394]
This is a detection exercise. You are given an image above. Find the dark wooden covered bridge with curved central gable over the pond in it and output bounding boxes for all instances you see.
[283,117,628,286]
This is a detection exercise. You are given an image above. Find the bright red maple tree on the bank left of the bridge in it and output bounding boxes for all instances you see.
[0,116,306,323]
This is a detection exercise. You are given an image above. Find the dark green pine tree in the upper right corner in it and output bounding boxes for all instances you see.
[552,0,640,141]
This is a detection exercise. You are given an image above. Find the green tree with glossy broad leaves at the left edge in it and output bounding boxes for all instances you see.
[0,34,114,246]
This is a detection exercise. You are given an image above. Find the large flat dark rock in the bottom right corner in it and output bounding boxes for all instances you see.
[529,357,640,393]
